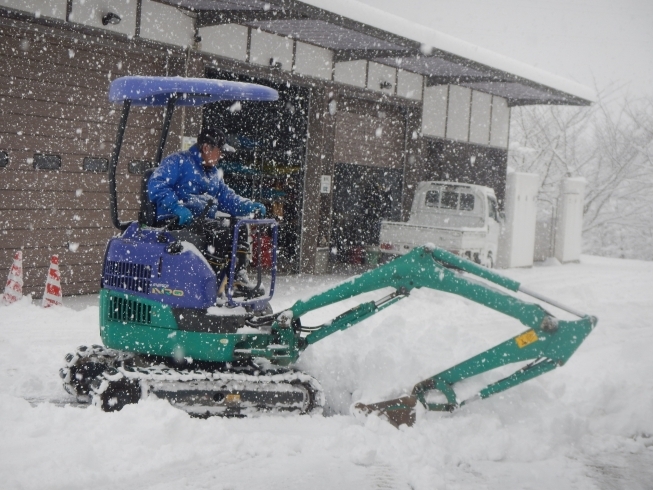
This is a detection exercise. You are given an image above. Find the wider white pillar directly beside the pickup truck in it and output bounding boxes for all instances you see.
[497,172,540,269]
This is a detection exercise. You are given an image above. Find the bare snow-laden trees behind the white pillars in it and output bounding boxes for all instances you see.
[509,93,653,260]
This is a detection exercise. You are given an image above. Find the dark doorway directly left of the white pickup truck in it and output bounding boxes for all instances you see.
[331,163,402,264]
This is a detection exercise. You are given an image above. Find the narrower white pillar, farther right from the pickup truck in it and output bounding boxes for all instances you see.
[554,178,585,263]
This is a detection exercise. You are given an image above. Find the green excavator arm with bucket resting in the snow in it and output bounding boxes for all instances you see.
[273,246,597,426]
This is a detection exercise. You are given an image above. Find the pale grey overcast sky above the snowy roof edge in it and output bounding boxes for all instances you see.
[359,0,653,97]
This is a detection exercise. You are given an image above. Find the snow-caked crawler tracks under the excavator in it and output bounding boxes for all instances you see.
[60,345,324,417]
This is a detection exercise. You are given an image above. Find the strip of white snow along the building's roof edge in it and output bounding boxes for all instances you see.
[303,0,596,101]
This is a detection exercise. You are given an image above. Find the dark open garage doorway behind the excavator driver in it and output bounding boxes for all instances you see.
[202,68,309,272]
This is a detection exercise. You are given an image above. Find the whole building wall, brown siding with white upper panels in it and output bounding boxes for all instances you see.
[0,0,509,288]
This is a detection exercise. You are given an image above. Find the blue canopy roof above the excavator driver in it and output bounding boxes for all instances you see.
[109,76,279,106]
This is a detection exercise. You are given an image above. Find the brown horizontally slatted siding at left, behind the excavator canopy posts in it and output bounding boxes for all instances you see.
[0,22,171,296]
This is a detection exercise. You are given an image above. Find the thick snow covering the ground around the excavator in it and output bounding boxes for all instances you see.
[0,256,653,490]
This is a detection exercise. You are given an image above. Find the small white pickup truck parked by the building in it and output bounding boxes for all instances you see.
[379,182,502,267]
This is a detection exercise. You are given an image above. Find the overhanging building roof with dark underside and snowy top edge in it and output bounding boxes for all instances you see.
[163,0,595,106]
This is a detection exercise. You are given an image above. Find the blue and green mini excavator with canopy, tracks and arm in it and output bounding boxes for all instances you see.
[60,77,597,427]
